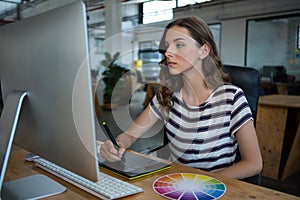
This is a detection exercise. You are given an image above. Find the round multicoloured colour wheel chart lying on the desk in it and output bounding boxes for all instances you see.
[153,173,226,200]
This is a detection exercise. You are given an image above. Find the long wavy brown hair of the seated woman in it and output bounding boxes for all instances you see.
[156,16,230,114]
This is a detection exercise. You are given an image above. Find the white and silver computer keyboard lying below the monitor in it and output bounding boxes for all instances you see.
[33,158,143,199]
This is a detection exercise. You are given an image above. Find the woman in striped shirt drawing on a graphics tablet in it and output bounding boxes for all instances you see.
[100,17,262,179]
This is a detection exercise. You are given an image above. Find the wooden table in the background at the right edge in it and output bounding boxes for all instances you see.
[256,95,300,179]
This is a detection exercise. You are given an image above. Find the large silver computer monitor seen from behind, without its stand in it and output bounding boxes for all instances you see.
[0,1,99,196]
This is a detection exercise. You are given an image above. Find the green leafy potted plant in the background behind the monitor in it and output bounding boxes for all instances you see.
[101,52,126,109]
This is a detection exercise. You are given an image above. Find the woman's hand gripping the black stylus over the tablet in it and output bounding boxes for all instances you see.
[100,140,125,162]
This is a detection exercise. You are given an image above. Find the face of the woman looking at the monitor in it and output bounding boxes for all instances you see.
[165,26,201,75]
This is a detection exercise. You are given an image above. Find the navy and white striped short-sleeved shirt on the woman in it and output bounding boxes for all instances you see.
[150,85,253,171]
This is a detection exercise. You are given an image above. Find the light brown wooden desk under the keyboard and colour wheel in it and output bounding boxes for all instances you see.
[5,147,300,200]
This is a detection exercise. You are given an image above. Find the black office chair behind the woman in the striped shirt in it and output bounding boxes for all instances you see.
[223,65,261,185]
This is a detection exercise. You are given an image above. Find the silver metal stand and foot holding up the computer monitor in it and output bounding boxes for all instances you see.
[0,91,66,200]
